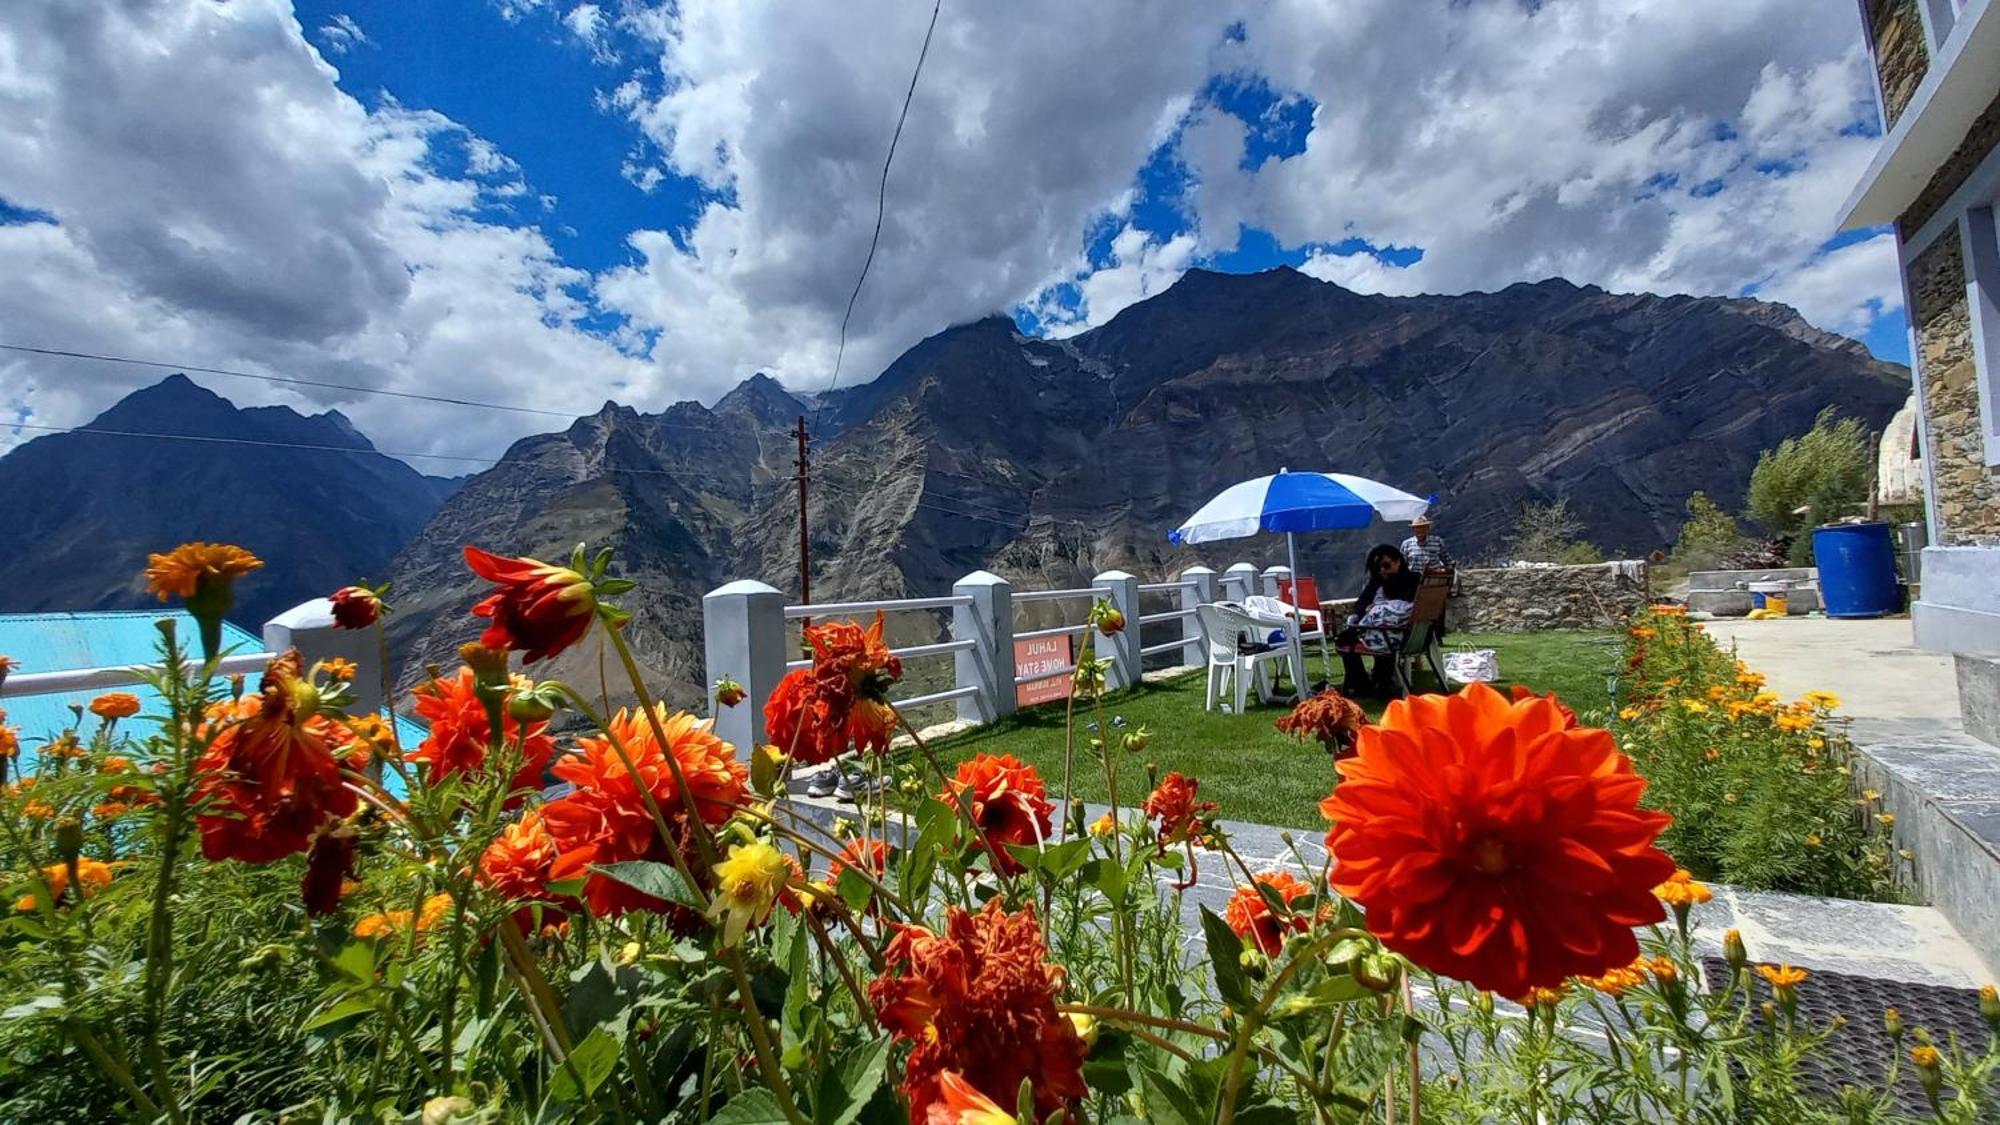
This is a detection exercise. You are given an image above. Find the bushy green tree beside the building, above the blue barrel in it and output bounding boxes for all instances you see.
[1744,406,1874,565]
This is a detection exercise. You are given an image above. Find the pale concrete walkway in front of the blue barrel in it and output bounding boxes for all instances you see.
[1704,617,1960,731]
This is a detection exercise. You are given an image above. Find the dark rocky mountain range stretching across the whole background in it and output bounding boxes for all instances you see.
[0,268,1910,703]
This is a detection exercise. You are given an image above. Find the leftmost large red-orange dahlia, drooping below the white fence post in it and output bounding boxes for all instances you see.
[194,651,360,863]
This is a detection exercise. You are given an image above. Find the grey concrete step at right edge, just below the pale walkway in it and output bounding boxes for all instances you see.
[1848,719,2000,965]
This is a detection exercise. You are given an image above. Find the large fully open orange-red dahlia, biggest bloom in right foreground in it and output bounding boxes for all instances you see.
[1320,685,1674,997]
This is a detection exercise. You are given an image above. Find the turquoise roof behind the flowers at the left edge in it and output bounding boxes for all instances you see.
[0,609,424,773]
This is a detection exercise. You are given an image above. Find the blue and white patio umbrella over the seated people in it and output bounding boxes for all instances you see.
[1166,470,1432,693]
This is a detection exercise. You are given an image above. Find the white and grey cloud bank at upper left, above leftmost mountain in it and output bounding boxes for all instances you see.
[0,0,644,460]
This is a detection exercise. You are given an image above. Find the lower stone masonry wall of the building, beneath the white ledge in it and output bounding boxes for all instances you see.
[1910,230,2000,546]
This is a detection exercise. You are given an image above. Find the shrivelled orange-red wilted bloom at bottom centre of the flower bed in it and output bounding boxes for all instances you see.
[868,899,1086,1121]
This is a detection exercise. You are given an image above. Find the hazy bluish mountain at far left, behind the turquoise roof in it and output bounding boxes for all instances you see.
[0,374,456,629]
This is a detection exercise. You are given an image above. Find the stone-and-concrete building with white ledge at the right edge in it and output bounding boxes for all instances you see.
[1842,0,2000,679]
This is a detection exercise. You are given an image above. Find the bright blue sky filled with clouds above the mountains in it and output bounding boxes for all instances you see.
[0,0,1908,454]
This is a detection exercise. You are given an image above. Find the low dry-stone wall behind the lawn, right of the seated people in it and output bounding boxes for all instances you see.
[1446,563,1652,633]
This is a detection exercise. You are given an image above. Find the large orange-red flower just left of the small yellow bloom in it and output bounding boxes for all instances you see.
[542,705,750,925]
